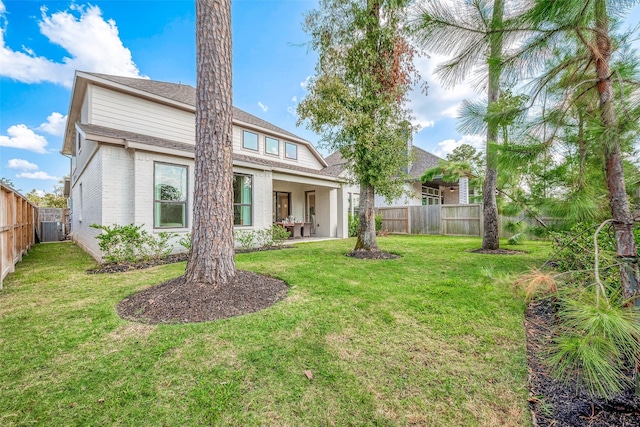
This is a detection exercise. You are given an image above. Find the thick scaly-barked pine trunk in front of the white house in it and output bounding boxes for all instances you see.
[185,0,236,286]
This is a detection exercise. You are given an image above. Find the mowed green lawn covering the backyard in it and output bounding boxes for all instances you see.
[0,236,549,427]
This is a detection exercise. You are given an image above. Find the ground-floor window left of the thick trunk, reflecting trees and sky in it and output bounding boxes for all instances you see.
[153,163,188,228]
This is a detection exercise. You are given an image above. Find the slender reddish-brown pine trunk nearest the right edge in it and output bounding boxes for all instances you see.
[593,0,640,305]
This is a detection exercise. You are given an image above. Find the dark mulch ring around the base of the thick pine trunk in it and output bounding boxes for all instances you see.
[116,270,288,324]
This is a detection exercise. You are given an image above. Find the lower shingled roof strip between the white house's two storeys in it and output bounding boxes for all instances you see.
[77,124,337,181]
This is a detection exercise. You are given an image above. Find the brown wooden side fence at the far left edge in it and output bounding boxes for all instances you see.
[0,184,38,289]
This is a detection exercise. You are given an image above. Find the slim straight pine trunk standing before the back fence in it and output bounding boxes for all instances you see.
[482,0,504,250]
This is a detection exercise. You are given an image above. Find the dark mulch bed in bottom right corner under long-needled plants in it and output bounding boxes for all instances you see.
[525,300,640,427]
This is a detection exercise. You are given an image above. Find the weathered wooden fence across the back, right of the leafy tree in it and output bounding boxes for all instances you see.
[376,204,557,238]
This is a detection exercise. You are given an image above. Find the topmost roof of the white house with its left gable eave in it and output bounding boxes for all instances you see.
[62,71,326,166]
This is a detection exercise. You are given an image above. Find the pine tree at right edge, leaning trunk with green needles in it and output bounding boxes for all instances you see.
[523,0,640,304]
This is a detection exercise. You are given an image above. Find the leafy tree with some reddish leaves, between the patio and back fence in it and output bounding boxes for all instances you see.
[298,0,418,251]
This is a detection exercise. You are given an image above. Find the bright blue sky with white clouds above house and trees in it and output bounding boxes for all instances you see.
[0,0,640,193]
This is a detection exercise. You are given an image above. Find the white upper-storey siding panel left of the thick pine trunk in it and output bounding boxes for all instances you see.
[89,86,195,144]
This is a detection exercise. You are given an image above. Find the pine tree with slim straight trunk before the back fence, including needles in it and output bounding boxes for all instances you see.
[416,0,521,249]
